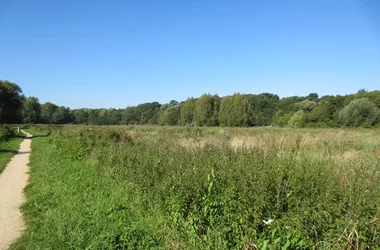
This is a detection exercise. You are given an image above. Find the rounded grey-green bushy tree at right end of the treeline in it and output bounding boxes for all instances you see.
[339,98,378,127]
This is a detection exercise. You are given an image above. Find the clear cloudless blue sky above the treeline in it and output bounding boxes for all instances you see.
[0,0,380,108]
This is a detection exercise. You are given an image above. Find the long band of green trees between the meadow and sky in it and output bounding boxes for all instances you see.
[0,80,380,128]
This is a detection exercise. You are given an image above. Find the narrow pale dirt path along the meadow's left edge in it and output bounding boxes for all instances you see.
[0,131,32,250]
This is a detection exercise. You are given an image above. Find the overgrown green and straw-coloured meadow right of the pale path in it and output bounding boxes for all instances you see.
[12,125,380,249]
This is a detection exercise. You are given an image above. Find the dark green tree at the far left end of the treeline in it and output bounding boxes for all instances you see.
[0,80,23,123]
